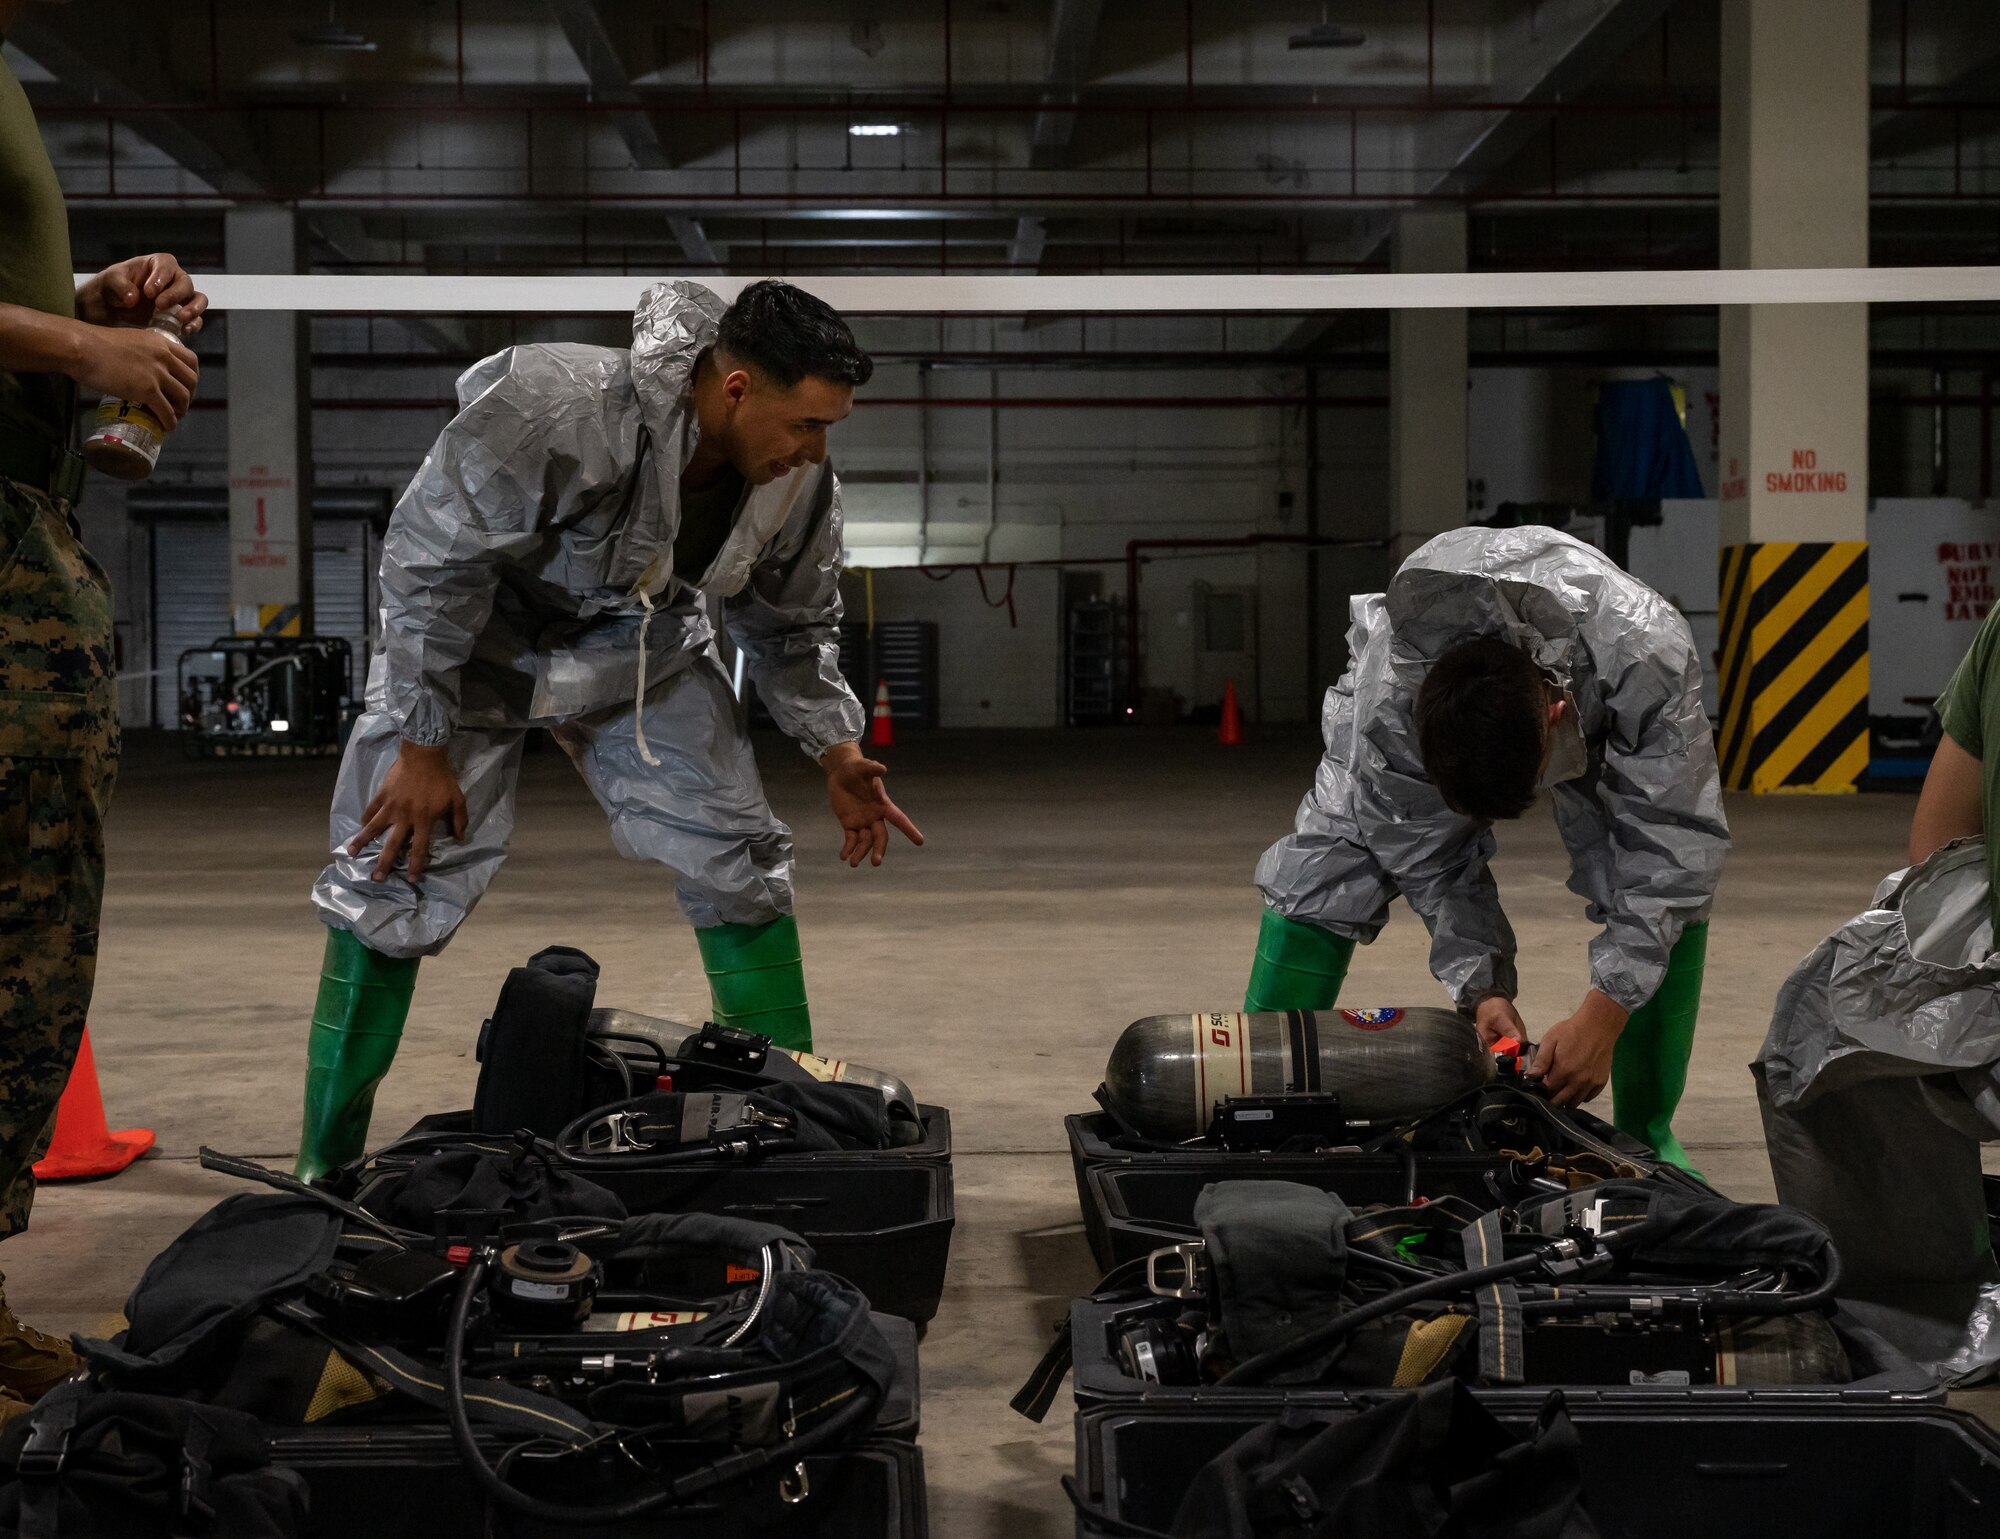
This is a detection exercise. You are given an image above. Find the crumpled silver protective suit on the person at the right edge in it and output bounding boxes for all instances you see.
[1750,839,2000,1383]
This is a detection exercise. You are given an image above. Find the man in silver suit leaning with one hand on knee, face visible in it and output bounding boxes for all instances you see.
[298,282,922,1179]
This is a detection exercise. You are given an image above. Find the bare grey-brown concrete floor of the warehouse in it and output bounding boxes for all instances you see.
[0,730,1952,1539]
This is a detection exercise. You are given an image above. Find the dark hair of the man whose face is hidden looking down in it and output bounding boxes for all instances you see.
[1416,636,1548,823]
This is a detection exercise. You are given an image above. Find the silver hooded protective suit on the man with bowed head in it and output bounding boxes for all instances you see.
[1256,528,1730,1009]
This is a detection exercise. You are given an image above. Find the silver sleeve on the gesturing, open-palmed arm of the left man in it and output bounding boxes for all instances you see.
[722,466,868,760]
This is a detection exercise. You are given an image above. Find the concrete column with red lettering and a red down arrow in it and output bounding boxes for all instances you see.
[222,206,312,636]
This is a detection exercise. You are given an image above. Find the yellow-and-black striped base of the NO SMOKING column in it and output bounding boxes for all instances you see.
[1716,540,1868,791]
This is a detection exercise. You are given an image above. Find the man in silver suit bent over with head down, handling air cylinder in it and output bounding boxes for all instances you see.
[1244,528,1730,1165]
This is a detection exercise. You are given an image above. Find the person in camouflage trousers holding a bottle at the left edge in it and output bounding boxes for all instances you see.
[0,0,208,1423]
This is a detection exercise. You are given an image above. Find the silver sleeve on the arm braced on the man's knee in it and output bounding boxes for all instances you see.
[382,346,630,746]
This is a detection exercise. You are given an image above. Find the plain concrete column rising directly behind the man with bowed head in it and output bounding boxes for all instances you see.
[1388,206,1466,562]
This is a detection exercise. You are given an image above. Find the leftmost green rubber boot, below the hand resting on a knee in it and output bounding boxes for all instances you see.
[292,929,418,1181]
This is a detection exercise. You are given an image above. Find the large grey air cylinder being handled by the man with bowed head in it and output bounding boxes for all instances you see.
[1104,1009,1494,1139]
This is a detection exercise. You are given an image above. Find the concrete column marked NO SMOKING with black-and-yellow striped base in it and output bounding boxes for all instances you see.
[1718,0,1868,791]
